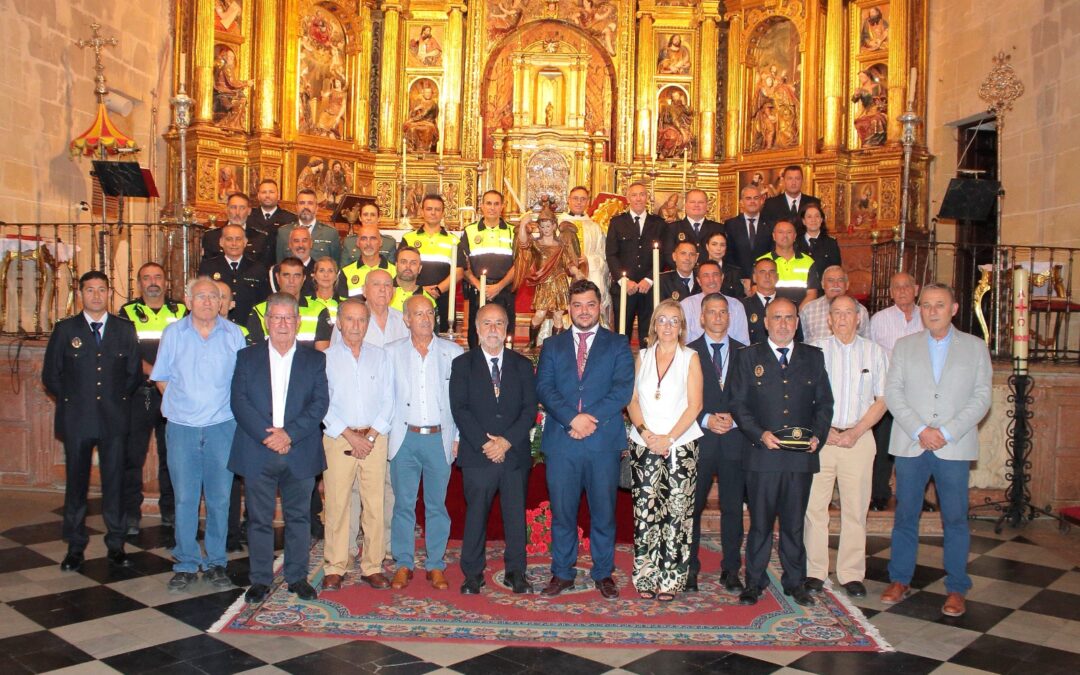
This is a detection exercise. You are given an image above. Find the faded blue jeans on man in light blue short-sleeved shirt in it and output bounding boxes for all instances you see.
[165,419,237,572]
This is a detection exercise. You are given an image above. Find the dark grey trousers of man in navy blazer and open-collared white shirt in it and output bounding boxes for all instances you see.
[244,454,315,585]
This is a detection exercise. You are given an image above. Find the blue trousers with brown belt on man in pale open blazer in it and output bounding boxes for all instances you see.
[390,431,450,570]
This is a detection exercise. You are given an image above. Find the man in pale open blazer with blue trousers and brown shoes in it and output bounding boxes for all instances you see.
[386,296,464,591]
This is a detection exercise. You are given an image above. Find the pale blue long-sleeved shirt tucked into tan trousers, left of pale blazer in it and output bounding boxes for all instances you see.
[323,341,394,438]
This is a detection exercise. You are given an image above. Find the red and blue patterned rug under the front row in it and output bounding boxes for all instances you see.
[211,533,892,651]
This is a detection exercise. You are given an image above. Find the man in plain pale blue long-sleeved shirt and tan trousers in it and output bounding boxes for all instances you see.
[323,298,394,591]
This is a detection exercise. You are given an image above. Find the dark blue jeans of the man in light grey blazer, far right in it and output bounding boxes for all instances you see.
[889,451,971,593]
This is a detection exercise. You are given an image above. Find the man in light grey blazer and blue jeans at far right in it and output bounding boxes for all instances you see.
[881,283,994,617]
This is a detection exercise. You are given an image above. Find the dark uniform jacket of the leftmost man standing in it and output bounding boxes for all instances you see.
[41,312,143,443]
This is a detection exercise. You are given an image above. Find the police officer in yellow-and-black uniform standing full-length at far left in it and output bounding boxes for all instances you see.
[120,262,188,537]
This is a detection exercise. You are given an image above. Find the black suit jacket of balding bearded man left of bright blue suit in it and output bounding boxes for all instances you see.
[450,347,537,469]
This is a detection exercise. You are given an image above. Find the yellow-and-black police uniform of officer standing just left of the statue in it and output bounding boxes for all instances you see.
[458,218,515,349]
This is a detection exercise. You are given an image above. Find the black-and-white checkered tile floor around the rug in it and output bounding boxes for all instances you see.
[0,491,1080,675]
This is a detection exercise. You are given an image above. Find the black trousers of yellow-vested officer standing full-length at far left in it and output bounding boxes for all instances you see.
[123,387,176,525]
